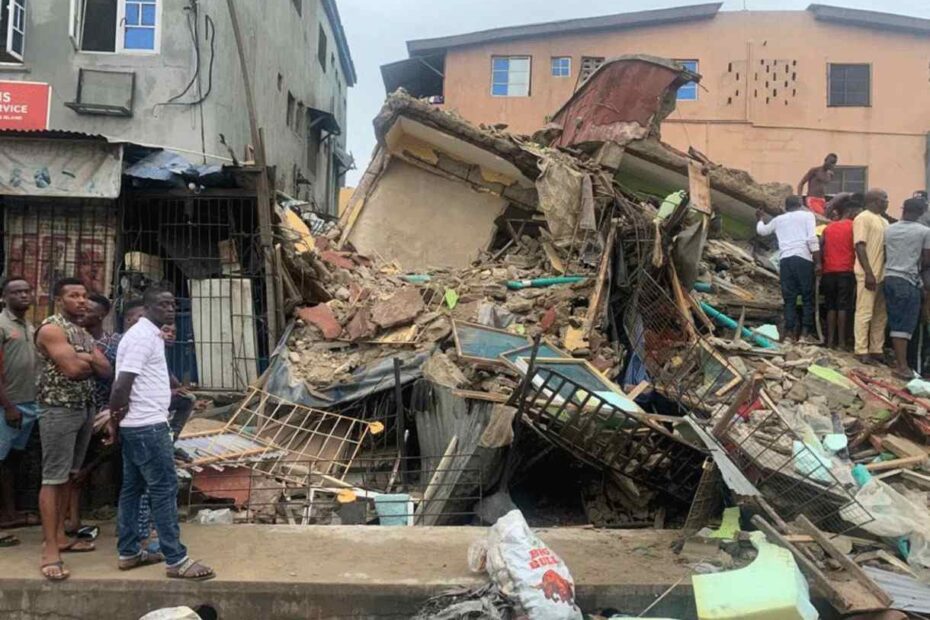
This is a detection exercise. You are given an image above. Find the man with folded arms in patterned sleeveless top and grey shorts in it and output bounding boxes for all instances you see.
[36,278,112,581]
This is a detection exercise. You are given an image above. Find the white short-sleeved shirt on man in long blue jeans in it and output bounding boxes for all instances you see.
[116,317,171,427]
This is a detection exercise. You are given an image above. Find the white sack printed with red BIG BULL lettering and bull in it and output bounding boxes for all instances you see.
[485,510,582,620]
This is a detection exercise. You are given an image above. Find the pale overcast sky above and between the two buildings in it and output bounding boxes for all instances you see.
[337,0,930,187]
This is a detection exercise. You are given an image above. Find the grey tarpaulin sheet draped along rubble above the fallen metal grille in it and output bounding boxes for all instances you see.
[265,322,432,410]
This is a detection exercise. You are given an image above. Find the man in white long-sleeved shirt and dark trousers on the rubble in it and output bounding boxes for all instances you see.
[756,196,820,343]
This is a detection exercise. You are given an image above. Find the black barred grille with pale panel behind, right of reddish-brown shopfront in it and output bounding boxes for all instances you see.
[118,191,268,391]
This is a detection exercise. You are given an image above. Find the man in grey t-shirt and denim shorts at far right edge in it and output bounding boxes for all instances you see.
[884,198,930,381]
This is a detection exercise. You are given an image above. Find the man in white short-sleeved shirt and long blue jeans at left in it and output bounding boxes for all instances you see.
[110,287,216,581]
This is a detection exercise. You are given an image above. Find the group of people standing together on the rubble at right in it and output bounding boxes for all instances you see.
[756,153,930,381]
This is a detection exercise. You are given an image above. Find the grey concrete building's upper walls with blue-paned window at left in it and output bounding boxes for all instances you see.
[0,0,356,213]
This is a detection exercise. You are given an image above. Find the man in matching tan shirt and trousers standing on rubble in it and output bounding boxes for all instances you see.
[853,189,888,364]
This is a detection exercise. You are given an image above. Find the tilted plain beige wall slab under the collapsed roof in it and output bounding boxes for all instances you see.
[349,158,507,270]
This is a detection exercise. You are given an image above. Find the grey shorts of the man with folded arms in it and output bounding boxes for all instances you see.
[39,405,94,485]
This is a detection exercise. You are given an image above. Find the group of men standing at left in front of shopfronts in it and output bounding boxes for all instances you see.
[0,276,215,581]
